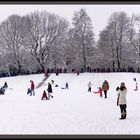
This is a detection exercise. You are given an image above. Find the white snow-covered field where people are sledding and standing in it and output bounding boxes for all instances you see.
[0,73,140,135]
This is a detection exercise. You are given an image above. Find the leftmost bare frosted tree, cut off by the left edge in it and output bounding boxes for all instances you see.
[0,15,25,74]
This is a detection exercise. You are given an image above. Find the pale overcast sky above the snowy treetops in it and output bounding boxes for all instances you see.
[0,4,140,39]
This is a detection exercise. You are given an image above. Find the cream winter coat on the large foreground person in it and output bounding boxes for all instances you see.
[118,89,127,105]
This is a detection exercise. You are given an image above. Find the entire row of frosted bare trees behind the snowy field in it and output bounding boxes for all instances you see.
[0,9,140,76]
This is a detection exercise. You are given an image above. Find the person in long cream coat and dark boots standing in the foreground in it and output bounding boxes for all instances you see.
[117,82,127,119]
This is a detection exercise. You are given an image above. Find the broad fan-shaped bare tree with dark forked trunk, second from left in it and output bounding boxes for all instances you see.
[26,11,68,71]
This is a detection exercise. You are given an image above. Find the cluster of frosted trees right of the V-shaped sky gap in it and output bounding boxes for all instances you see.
[98,12,140,71]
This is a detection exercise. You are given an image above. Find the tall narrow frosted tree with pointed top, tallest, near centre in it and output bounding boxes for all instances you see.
[73,9,94,71]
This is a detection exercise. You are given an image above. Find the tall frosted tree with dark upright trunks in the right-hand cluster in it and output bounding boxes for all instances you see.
[108,12,130,70]
